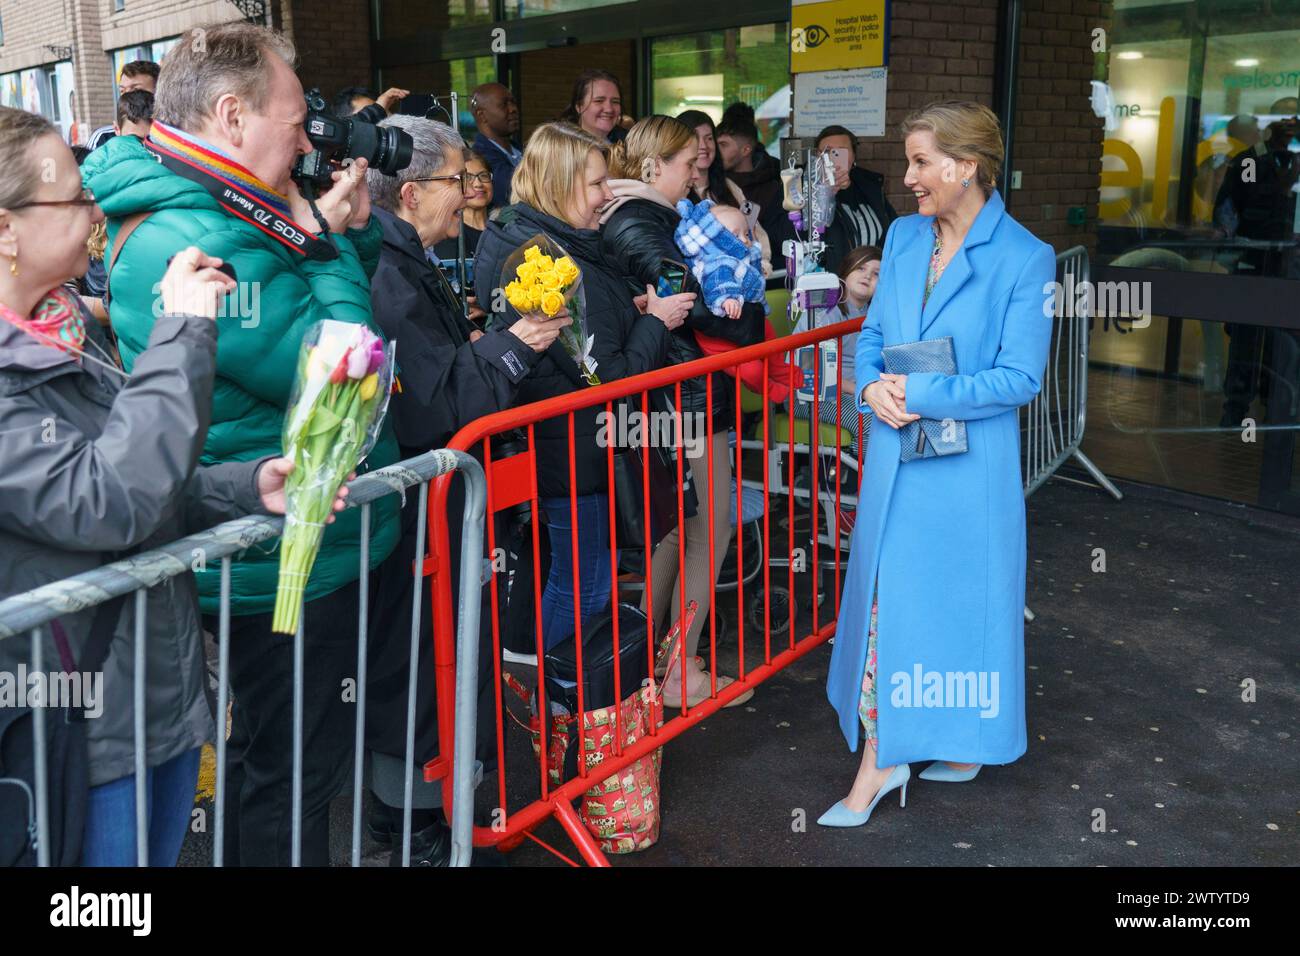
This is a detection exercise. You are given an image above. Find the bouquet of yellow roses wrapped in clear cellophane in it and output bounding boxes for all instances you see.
[501,233,601,385]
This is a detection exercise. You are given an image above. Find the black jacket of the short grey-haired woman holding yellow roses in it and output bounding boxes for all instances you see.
[371,209,541,458]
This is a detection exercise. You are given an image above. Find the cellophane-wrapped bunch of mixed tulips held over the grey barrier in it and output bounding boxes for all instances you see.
[272,319,397,633]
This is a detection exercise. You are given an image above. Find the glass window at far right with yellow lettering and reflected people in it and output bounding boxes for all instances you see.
[1093,13,1300,278]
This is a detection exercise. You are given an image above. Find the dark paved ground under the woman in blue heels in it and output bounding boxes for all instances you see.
[186,480,1300,866]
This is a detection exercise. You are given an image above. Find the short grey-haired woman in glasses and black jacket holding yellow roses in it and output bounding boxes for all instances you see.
[367,116,571,862]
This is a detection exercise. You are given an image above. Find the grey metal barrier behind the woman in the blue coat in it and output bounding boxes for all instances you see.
[1021,246,1125,501]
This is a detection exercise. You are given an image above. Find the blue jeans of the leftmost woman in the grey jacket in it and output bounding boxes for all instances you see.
[82,747,199,866]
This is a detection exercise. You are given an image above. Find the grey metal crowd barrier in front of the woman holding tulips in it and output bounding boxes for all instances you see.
[0,449,486,866]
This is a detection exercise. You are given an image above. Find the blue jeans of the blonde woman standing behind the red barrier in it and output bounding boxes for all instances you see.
[540,494,612,650]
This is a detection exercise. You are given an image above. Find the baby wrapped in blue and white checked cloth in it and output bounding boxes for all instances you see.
[673,199,768,319]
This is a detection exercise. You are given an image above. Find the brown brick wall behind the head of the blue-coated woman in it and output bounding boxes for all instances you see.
[858,0,1110,251]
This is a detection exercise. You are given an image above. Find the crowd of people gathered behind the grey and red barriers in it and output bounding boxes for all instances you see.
[0,14,1041,865]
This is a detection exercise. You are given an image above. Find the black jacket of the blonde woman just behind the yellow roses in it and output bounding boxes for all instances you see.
[475,203,668,497]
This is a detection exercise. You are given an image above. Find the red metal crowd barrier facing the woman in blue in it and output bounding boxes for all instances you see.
[424,319,865,865]
